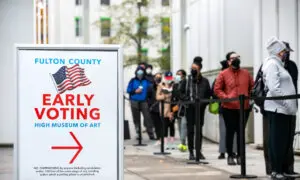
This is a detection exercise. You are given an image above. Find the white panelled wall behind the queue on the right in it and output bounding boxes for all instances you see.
[171,0,300,148]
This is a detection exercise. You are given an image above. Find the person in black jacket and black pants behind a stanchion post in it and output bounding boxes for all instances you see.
[186,56,211,160]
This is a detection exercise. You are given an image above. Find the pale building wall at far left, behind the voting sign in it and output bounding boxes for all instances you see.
[0,0,35,144]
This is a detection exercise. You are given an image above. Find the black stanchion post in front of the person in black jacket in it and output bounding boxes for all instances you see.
[188,98,208,164]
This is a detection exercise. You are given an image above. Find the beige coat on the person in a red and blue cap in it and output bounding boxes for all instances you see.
[156,83,173,119]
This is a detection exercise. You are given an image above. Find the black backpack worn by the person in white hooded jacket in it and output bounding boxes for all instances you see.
[251,65,267,108]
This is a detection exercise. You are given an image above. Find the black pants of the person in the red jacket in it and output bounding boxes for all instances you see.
[223,108,250,156]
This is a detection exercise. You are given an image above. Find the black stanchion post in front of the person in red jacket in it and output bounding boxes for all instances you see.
[230,95,257,179]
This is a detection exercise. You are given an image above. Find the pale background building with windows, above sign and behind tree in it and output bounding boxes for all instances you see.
[36,0,170,58]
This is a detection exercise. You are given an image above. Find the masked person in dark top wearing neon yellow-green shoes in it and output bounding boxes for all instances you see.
[172,69,187,152]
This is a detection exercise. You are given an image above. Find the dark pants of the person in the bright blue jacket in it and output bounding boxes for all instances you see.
[130,101,153,137]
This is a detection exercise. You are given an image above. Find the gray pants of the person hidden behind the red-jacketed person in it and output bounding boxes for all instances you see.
[219,114,237,153]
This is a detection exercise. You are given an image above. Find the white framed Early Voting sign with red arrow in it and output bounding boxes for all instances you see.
[15,45,123,180]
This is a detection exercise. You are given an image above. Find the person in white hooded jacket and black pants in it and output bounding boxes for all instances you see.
[262,37,297,179]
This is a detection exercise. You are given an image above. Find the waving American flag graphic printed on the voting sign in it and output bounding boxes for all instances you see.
[51,64,91,94]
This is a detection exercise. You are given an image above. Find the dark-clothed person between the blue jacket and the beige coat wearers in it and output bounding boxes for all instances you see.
[150,73,162,145]
